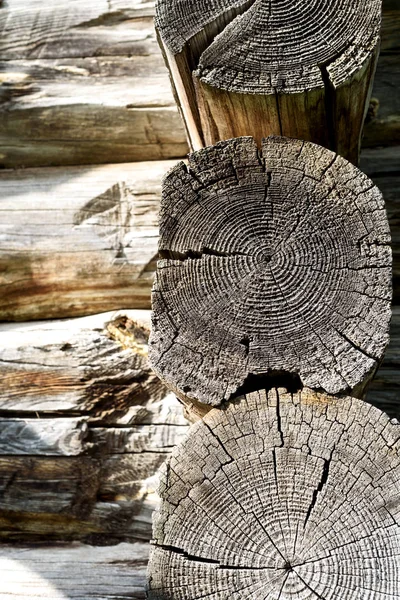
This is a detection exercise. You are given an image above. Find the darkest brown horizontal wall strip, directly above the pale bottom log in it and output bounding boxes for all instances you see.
[0,448,167,543]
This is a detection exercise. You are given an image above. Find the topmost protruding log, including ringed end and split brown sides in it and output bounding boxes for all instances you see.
[156,0,382,164]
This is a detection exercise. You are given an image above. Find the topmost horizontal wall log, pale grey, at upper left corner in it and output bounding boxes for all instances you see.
[0,0,159,60]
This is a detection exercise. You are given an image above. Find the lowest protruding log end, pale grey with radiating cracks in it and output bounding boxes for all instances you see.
[148,389,400,600]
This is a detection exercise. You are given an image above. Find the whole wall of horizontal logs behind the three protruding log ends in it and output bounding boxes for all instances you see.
[0,0,400,600]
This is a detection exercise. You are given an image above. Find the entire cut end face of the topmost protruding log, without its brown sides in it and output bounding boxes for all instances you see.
[156,0,382,88]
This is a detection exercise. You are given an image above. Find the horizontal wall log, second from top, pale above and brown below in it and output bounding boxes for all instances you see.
[0,55,187,168]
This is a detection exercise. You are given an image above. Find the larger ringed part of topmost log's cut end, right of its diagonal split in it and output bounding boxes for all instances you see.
[197,0,381,94]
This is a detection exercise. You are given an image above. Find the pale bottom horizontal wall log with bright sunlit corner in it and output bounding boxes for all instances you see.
[0,542,149,600]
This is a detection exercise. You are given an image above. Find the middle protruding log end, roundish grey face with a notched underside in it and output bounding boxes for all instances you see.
[149,137,391,412]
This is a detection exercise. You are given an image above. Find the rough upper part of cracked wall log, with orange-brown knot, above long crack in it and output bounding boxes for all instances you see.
[0,311,185,426]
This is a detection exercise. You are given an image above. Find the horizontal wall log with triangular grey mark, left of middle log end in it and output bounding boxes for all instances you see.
[0,161,174,321]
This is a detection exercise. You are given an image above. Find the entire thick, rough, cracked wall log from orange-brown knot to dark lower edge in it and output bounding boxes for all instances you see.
[0,311,187,543]
